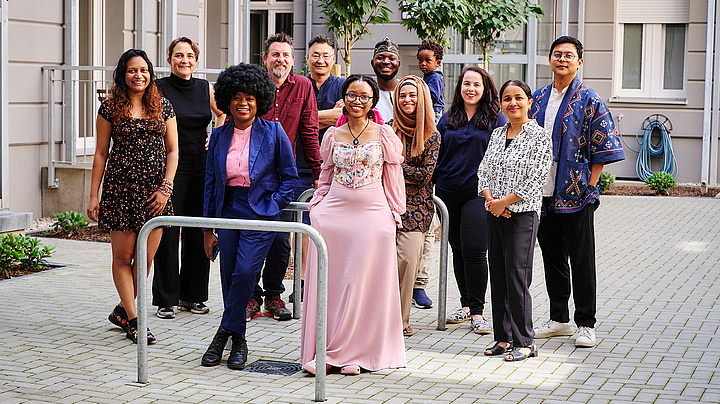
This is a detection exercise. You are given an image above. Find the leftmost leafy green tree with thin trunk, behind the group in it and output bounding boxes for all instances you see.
[318,0,390,77]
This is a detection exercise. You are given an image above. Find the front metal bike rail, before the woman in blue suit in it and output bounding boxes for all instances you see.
[136,213,328,401]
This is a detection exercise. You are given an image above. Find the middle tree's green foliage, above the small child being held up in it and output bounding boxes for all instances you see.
[399,0,469,47]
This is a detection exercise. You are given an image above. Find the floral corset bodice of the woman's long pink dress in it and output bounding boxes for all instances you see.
[333,141,383,188]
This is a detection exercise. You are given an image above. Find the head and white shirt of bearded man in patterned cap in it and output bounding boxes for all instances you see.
[370,37,400,123]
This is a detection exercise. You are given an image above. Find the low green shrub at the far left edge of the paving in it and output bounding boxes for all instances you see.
[0,234,55,278]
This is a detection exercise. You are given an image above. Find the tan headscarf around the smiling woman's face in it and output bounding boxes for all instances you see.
[392,75,437,157]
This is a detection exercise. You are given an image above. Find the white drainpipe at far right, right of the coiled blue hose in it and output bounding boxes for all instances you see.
[700,0,716,193]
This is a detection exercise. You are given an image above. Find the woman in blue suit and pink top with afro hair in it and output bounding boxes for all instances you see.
[202,63,298,369]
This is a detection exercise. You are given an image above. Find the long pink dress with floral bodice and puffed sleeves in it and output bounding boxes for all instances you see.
[300,125,406,371]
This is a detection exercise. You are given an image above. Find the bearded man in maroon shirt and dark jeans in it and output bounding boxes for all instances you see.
[246,32,322,321]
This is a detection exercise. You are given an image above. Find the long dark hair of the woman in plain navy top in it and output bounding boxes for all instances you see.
[447,66,500,130]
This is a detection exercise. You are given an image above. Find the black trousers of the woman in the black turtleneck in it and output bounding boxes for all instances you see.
[152,153,210,307]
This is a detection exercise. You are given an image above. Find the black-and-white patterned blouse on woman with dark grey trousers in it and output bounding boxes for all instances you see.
[478,120,552,216]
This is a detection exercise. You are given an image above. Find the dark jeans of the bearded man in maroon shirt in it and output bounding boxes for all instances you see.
[252,175,313,303]
